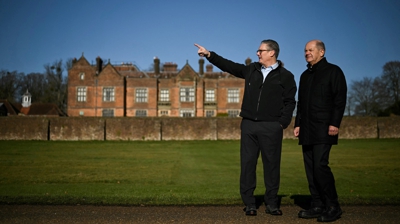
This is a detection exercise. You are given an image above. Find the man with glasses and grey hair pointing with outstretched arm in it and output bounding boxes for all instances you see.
[195,40,297,215]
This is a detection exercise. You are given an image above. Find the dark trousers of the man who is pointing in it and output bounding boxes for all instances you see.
[240,119,283,208]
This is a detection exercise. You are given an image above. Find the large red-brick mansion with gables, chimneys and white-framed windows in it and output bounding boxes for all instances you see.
[67,55,251,117]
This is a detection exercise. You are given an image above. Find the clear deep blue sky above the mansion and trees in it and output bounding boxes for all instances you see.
[0,0,400,82]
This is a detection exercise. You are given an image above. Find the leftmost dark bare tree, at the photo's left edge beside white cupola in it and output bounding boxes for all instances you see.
[0,70,24,102]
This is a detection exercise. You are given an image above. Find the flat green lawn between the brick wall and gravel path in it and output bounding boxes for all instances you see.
[0,139,400,205]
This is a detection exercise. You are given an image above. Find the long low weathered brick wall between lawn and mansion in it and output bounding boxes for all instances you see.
[0,116,400,141]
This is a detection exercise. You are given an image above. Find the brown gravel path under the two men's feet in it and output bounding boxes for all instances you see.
[0,205,400,224]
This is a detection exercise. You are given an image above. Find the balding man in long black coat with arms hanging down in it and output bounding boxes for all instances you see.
[294,40,347,222]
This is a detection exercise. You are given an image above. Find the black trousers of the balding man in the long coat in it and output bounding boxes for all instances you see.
[302,144,339,207]
